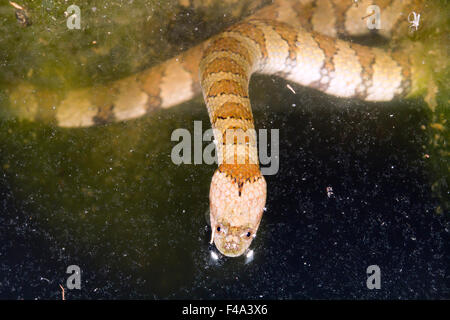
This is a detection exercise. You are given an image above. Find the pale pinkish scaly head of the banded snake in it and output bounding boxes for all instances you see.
[209,166,266,257]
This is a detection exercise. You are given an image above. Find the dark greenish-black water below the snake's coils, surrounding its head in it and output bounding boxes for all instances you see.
[0,0,450,299]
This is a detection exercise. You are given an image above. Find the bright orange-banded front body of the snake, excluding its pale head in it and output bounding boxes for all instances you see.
[200,19,411,175]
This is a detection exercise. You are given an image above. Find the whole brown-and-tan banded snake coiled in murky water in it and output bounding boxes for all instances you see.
[10,0,422,257]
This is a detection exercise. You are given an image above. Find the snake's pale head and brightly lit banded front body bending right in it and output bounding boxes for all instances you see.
[200,15,411,256]
